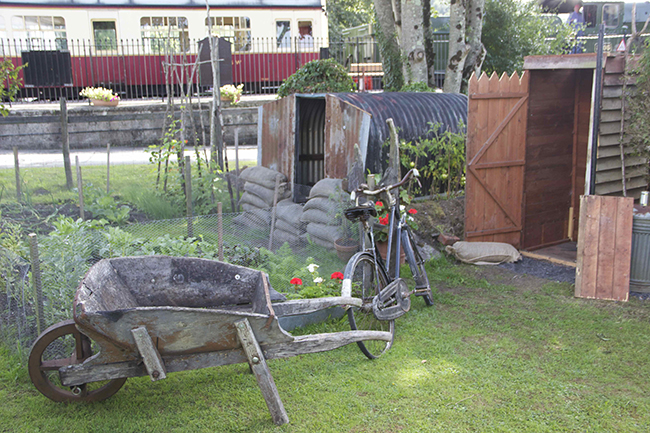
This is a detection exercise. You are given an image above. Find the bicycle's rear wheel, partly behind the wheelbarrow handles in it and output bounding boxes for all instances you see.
[344,252,395,359]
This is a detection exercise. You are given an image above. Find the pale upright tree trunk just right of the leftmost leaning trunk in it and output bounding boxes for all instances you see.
[401,0,429,84]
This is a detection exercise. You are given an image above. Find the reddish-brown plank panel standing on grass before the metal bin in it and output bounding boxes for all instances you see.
[575,195,634,301]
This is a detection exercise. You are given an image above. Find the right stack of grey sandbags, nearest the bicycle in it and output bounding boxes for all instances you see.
[300,179,350,248]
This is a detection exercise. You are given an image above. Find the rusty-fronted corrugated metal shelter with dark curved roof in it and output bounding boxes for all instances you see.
[257,92,467,201]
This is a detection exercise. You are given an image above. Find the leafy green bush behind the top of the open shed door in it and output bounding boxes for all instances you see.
[481,0,575,74]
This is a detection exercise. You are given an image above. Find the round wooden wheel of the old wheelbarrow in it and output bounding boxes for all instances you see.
[28,319,126,402]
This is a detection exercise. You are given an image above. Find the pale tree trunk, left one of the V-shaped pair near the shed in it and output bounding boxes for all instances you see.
[443,0,468,93]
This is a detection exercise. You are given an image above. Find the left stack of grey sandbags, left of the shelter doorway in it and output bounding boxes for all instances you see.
[233,165,290,230]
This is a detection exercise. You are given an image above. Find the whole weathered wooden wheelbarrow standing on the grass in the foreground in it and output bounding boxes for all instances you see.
[29,256,392,424]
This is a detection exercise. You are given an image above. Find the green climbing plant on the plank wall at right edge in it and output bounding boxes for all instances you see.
[625,38,650,183]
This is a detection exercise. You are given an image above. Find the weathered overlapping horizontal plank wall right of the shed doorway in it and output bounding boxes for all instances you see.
[596,54,647,198]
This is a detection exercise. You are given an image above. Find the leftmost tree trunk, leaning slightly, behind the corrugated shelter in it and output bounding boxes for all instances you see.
[374,0,404,90]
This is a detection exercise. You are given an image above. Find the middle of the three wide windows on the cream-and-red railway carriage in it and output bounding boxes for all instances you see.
[140,17,190,53]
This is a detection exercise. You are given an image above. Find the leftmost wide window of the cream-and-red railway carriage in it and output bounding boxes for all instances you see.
[11,15,68,50]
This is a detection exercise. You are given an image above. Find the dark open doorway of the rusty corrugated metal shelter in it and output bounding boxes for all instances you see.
[293,96,325,203]
